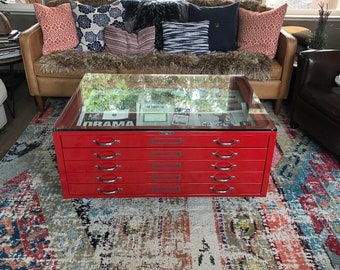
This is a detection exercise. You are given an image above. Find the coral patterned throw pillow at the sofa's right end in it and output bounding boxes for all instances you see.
[238,4,287,59]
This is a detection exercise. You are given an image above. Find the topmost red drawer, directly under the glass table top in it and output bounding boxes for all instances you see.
[59,130,270,148]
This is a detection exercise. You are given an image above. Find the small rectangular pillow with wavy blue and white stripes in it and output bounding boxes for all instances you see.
[162,20,210,54]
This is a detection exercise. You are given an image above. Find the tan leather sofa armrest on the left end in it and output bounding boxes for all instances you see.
[19,23,43,96]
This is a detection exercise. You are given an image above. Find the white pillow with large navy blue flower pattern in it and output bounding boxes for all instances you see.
[71,1,125,52]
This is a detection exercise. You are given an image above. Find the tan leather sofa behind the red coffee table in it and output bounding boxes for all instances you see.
[20,0,297,113]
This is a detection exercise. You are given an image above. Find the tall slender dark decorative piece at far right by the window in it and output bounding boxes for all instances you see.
[309,2,331,49]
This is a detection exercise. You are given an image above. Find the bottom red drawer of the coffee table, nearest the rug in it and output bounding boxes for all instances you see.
[69,184,262,198]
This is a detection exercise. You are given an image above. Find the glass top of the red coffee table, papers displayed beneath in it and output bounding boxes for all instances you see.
[55,73,275,130]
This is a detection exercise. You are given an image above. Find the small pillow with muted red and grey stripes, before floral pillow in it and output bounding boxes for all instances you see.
[104,25,155,55]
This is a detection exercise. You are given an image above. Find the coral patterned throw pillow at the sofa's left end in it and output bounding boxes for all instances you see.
[33,3,79,55]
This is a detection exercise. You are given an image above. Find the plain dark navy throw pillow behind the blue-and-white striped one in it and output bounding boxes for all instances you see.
[189,3,239,51]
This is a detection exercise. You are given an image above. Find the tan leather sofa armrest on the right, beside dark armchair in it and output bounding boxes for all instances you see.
[275,29,297,99]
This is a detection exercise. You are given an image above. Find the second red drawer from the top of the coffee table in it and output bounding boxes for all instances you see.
[63,148,267,161]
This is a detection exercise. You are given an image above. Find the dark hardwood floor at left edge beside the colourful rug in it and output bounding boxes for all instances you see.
[0,80,38,160]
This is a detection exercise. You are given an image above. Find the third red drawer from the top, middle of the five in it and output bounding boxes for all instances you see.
[66,160,265,173]
